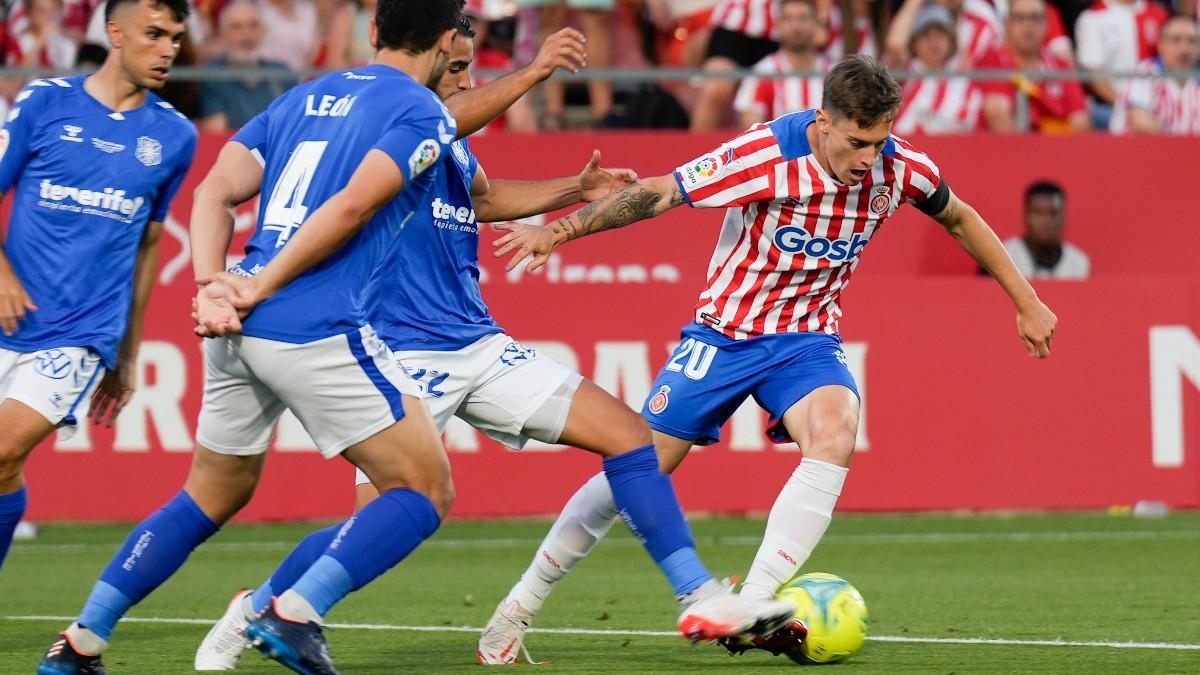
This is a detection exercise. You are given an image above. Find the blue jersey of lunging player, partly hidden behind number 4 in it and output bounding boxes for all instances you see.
[365,134,502,352]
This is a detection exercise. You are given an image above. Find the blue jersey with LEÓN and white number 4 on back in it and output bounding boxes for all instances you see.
[232,64,456,342]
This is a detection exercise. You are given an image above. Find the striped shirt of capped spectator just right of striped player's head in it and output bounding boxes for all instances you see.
[892,69,983,136]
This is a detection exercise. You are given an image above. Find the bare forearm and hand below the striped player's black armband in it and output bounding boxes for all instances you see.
[934,193,1058,358]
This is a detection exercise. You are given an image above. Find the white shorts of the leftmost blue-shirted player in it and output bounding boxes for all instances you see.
[0,347,104,430]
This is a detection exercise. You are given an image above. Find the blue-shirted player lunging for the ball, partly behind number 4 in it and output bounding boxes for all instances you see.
[194,17,792,670]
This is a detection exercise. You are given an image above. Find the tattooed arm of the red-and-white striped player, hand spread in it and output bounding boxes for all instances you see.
[493,173,683,271]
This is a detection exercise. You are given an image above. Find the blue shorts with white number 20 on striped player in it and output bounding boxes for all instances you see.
[642,323,859,446]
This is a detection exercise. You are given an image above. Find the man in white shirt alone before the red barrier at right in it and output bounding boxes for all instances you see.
[1004,180,1092,279]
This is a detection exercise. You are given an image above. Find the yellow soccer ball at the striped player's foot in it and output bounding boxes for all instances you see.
[776,573,868,663]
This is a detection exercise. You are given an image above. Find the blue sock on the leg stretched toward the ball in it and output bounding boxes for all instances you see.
[604,446,713,596]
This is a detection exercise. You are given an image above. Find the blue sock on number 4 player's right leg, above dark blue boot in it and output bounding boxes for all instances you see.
[292,488,442,616]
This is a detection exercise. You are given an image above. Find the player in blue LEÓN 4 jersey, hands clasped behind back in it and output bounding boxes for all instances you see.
[40,0,462,674]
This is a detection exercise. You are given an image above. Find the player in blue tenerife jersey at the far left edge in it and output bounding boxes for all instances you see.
[0,0,196,565]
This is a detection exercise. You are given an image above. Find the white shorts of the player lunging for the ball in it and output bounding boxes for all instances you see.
[355,334,583,485]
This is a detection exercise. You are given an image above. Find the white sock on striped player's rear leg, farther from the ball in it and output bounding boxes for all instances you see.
[504,472,617,614]
